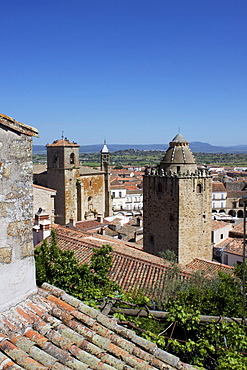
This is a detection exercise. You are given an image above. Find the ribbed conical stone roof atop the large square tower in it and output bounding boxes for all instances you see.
[160,134,197,173]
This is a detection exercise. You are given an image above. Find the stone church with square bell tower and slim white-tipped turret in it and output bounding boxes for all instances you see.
[34,138,112,225]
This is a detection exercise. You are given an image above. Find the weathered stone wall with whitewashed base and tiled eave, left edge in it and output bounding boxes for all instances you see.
[0,114,38,311]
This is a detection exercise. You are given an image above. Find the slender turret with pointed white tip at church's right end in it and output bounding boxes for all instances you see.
[100,140,112,217]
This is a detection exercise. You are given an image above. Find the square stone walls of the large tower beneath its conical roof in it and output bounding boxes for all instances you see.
[143,175,212,264]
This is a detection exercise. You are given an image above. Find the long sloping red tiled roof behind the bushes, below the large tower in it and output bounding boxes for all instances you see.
[39,226,233,298]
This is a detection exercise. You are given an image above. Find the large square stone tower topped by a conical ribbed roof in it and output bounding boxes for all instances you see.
[143,134,212,264]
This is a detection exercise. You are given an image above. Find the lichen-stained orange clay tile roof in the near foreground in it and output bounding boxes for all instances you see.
[0,284,188,370]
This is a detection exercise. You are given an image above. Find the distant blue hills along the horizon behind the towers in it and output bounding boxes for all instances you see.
[33,141,247,154]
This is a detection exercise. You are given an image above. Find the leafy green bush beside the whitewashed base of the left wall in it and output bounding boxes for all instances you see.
[35,230,120,300]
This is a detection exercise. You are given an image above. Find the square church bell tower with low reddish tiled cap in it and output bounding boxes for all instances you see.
[46,138,80,225]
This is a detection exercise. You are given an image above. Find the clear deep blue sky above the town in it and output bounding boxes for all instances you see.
[0,0,247,145]
